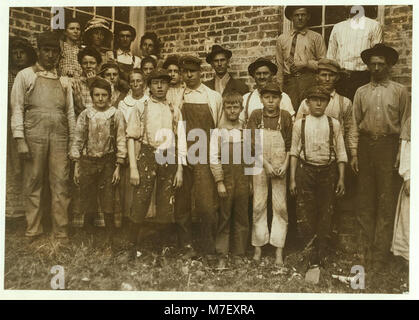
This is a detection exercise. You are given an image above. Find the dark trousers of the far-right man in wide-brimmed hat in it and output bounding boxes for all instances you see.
[358,135,402,261]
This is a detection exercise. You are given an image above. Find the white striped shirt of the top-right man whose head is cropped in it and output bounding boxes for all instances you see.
[327,16,383,71]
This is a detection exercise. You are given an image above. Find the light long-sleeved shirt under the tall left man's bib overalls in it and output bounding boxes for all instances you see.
[10,64,76,142]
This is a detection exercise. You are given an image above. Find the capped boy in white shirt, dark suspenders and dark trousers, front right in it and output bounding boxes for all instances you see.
[290,86,348,267]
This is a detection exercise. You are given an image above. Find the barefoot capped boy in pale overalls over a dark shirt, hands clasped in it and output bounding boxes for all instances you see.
[248,82,292,265]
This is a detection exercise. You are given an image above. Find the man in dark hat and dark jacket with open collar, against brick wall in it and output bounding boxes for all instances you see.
[204,44,249,95]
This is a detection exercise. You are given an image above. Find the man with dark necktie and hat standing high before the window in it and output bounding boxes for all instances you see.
[276,6,326,111]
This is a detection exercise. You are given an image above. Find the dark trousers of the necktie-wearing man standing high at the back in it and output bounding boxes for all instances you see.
[284,71,315,113]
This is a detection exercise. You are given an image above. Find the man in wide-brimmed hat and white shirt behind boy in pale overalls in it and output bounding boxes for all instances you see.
[240,58,295,124]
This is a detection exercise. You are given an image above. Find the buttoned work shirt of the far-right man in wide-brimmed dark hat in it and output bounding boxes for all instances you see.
[353,80,411,154]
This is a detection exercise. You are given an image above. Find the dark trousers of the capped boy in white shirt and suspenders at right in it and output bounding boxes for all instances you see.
[295,161,337,251]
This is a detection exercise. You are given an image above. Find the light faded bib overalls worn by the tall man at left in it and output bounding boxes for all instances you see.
[24,76,70,237]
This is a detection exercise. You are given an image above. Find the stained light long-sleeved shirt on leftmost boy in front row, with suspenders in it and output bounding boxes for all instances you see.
[70,107,127,163]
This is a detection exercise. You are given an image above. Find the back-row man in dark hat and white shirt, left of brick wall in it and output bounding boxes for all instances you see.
[113,24,141,81]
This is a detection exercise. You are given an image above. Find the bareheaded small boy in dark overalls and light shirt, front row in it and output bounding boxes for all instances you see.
[210,91,251,269]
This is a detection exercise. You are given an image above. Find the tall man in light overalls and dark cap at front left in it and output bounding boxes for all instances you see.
[11,32,75,241]
